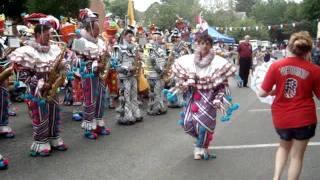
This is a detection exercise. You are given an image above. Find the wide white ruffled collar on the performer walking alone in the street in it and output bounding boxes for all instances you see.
[172,54,236,90]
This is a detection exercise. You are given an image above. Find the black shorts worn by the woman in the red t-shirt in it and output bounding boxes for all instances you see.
[276,124,317,141]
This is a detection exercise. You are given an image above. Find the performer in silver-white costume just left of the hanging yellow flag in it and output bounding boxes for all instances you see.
[114,29,143,125]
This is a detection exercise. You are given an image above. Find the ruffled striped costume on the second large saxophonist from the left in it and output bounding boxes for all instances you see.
[72,31,110,139]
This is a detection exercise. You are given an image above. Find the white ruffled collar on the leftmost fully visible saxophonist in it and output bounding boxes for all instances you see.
[9,45,61,72]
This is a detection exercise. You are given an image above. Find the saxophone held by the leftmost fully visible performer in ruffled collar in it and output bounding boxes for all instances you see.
[42,43,67,102]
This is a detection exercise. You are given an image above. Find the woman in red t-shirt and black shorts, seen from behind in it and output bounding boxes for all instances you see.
[259,32,320,180]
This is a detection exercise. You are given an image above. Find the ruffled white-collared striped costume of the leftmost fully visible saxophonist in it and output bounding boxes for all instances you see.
[9,41,67,156]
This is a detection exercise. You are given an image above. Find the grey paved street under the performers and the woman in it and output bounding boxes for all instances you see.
[0,79,320,180]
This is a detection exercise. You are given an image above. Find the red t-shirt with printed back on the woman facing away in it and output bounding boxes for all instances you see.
[261,57,320,128]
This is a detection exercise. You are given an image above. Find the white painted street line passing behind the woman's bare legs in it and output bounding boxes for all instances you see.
[209,142,320,149]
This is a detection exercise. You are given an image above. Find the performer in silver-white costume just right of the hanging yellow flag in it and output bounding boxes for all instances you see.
[145,29,167,115]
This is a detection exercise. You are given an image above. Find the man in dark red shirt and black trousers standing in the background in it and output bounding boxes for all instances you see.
[238,35,252,87]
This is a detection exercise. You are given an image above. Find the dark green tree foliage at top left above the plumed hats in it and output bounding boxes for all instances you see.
[27,0,89,17]
